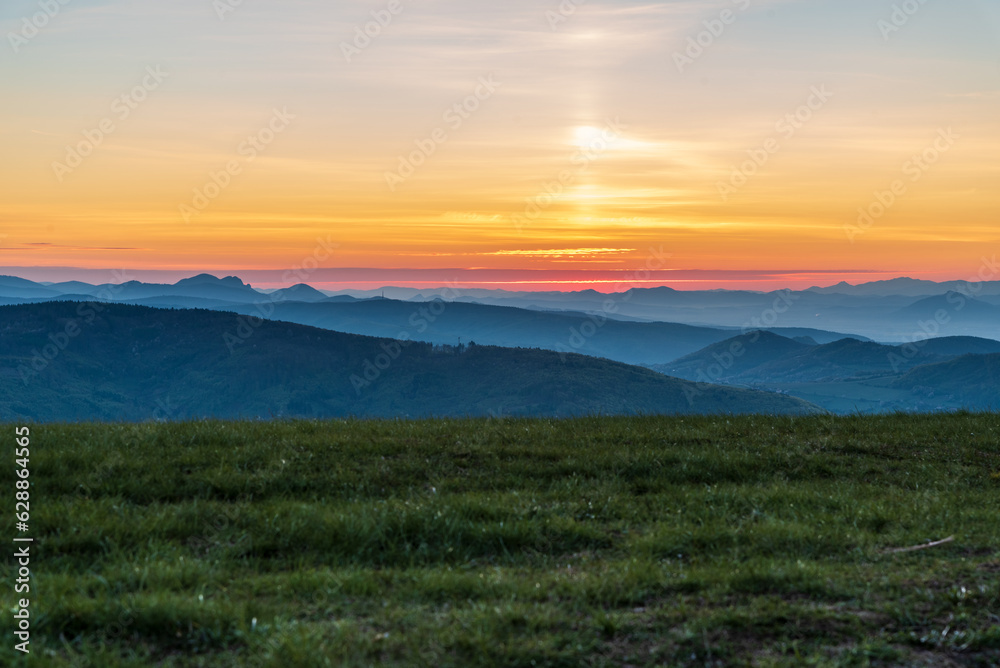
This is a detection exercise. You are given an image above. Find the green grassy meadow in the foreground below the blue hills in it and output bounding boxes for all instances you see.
[0,414,1000,668]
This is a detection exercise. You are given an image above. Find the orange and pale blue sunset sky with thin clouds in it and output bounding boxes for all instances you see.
[0,0,1000,291]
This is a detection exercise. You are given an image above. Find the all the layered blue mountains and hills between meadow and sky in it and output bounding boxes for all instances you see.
[0,274,1000,419]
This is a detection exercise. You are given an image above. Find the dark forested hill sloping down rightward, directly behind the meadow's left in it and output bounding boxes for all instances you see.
[0,302,816,421]
